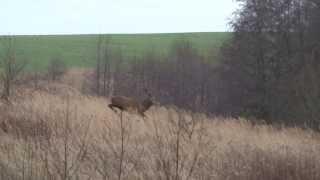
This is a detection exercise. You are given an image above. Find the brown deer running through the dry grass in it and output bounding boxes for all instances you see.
[108,90,154,118]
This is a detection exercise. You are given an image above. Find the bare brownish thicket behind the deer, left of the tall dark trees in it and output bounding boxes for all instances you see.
[91,37,219,112]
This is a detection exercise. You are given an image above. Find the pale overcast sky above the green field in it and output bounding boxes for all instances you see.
[0,0,236,35]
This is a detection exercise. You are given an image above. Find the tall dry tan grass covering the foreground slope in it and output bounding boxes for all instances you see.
[0,71,320,180]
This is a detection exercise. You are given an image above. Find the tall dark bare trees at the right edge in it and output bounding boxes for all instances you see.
[217,0,320,130]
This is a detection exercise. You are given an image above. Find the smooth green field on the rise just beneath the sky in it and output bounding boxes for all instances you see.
[0,32,231,70]
